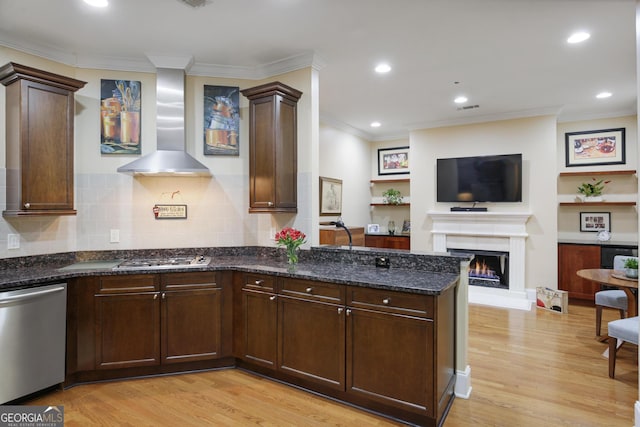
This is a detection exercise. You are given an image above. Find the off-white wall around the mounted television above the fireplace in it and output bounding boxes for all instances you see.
[410,116,558,288]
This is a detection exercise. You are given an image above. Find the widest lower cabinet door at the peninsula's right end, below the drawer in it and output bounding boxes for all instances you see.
[346,309,435,416]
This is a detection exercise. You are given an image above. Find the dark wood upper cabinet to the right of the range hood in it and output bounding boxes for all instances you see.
[242,82,302,213]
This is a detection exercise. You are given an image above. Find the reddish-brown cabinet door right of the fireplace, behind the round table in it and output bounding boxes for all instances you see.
[558,244,600,301]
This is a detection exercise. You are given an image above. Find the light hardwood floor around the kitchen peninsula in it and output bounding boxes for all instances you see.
[25,304,638,427]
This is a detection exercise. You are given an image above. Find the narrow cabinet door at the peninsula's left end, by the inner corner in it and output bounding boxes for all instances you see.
[242,288,278,369]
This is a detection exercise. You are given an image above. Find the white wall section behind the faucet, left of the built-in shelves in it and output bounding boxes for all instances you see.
[318,124,371,227]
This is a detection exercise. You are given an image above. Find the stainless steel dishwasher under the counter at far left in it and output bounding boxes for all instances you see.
[0,283,67,404]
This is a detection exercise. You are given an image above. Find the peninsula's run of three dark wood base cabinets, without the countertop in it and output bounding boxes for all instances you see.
[236,275,455,426]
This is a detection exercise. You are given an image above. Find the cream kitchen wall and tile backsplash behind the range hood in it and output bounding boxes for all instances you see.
[0,47,318,258]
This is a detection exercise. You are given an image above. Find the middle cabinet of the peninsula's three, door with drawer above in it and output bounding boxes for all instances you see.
[278,279,345,390]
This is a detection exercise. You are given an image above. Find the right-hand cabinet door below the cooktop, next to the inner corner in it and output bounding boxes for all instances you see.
[161,288,222,363]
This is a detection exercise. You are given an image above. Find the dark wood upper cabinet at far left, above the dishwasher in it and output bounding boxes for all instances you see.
[0,62,86,216]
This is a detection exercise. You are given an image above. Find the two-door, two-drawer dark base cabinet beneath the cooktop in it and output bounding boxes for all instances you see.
[67,272,232,383]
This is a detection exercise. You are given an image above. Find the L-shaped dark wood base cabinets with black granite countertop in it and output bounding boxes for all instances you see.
[0,247,468,426]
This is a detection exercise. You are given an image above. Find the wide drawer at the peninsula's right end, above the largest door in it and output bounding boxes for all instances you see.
[347,286,434,318]
